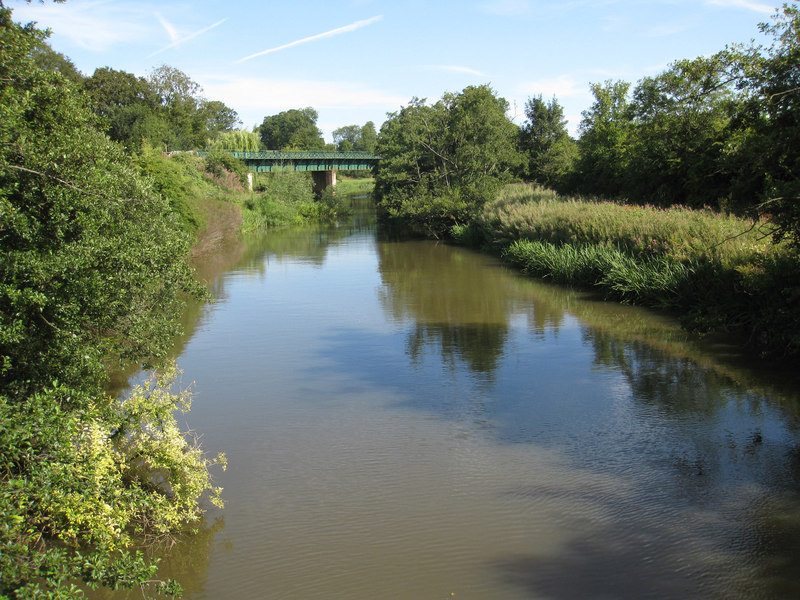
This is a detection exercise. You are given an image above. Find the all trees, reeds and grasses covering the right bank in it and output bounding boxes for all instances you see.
[375,4,800,358]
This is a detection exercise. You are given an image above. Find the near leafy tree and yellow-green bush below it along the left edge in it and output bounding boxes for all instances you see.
[0,9,219,598]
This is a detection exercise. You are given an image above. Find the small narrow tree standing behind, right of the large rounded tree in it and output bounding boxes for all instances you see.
[520,95,577,189]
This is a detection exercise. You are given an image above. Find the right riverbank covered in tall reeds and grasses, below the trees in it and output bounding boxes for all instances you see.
[453,184,800,360]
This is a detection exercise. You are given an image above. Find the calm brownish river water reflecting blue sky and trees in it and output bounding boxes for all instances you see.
[108,200,800,600]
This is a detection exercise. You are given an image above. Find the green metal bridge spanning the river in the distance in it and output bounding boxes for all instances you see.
[198,150,379,192]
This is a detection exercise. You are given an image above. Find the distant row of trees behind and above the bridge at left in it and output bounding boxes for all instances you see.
[31,40,378,152]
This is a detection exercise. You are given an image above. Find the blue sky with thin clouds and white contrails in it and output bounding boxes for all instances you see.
[6,0,779,141]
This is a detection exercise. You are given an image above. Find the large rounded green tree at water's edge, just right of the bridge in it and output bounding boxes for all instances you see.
[375,86,521,237]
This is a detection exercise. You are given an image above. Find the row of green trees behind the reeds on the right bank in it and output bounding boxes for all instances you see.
[376,4,800,245]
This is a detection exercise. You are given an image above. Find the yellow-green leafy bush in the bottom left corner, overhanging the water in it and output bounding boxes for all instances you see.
[0,369,224,599]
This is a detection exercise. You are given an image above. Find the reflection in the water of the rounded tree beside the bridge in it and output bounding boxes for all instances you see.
[378,242,520,375]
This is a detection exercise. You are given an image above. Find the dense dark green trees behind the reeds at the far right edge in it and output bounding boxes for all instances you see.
[570,4,800,247]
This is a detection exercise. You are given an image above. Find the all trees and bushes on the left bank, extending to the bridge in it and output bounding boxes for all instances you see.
[0,2,362,600]
